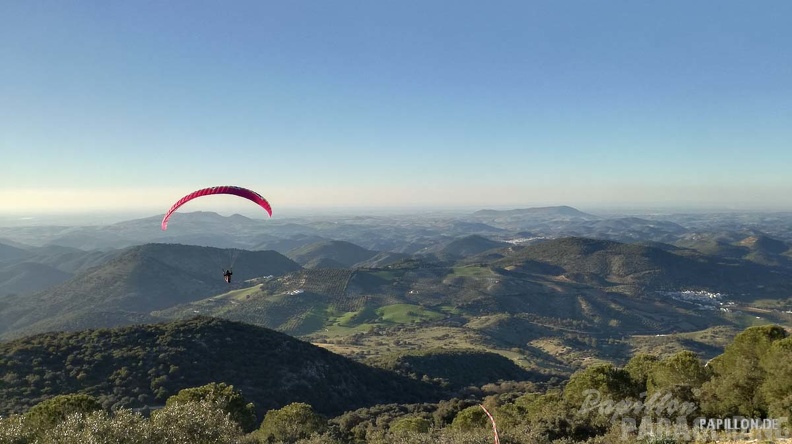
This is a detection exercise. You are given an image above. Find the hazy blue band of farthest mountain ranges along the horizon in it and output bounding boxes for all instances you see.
[0,206,792,251]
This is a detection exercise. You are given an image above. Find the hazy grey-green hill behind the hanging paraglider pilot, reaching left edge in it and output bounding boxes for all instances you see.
[0,244,301,338]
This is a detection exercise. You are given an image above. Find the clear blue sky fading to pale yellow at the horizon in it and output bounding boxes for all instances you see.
[0,0,792,214]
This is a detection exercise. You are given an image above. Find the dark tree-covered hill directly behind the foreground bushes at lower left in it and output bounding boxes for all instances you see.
[0,318,443,416]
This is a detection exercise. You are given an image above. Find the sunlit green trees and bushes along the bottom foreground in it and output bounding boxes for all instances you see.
[0,320,792,444]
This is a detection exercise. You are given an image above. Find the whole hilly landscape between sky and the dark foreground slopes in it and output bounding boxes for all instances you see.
[0,207,792,377]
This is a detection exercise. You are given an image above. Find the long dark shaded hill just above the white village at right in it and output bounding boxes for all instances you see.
[492,238,792,300]
